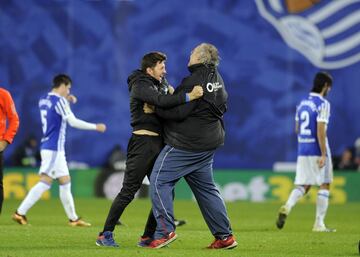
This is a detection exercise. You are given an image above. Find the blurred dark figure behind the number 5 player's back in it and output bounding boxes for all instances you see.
[12,135,41,167]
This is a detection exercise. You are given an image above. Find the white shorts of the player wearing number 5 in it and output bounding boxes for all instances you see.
[39,150,69,179]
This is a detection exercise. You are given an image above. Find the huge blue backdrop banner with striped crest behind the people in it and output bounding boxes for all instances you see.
[0,0,360,169]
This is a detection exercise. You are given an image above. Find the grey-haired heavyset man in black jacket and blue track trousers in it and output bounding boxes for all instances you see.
[146,43,237,249]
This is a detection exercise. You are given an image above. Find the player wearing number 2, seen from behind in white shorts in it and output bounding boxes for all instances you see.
[276,72,335,232]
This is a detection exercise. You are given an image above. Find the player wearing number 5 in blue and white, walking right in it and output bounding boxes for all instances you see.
[12,74,106,226]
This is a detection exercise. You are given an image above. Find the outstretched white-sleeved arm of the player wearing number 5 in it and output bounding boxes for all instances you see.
[55,98,106,132]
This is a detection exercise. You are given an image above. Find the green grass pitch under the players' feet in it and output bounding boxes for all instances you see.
[0,199,360,257]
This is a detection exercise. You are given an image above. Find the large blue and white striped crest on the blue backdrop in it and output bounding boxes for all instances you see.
[256,0,360,69]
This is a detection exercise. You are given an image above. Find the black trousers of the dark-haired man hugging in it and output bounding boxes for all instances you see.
[103,134,163,236]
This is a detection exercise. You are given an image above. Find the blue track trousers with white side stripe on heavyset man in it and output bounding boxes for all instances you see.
[150,145,232,239]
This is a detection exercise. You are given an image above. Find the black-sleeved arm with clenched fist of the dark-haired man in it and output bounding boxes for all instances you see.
[130,82,203,108]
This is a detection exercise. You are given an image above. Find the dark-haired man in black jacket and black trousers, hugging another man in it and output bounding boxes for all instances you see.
[96,52,203,247]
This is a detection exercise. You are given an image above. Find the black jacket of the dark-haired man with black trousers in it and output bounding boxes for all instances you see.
[127,70,186,134]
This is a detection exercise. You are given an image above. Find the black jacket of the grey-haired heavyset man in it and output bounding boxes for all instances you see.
[156,64,228,152]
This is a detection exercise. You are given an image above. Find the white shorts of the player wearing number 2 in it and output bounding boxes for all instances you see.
[294,156,333,186]
